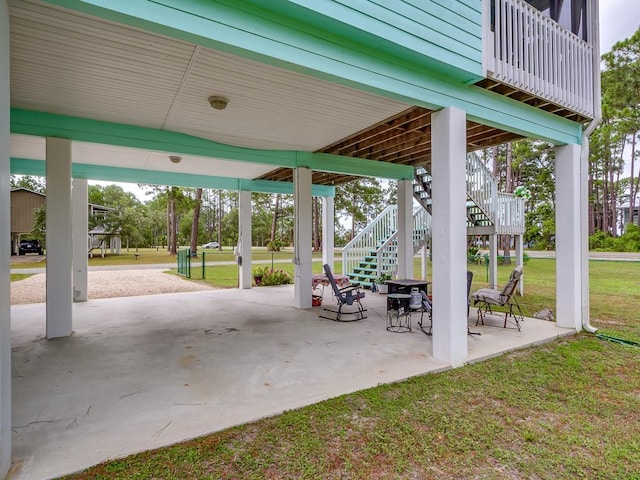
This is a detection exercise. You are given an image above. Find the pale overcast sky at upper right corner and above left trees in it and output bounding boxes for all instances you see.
[95,0,640,201]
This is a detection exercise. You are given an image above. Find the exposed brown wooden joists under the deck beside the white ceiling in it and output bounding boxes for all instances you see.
[260,107,522,185]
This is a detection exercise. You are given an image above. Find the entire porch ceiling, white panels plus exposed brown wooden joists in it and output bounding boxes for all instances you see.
[10,0,518,185]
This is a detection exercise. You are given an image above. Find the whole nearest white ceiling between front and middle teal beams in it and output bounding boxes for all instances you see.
[10,0,408,156]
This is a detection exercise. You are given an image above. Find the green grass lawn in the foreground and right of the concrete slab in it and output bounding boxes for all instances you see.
[56,259,640,480]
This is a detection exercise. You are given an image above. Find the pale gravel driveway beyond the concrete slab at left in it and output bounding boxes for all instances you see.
[11,269,214,305]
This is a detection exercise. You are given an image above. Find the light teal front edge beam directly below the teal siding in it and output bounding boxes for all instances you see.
[41,0,582,145]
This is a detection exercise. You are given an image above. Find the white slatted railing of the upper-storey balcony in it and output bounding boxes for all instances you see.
[484,0,594,118]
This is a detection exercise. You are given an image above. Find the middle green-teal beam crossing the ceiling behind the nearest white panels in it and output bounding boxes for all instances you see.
[11,108,413,180]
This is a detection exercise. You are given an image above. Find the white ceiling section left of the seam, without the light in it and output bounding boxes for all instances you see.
[10,1,195,128]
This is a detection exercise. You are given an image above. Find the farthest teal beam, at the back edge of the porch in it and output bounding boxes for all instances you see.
[11,158,336,197]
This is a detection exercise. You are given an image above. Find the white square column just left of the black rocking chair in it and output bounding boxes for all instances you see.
[293,167,312,308]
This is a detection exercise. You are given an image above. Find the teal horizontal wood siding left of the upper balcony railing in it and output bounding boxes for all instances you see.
[288,0,482,82]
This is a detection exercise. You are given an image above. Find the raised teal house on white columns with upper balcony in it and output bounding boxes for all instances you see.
[0,0,600,476]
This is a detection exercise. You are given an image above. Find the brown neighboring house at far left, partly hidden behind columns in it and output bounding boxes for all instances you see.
[11,188,121,256]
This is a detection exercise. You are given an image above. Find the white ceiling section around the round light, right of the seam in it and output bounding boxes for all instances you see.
[162,49,407,151]
